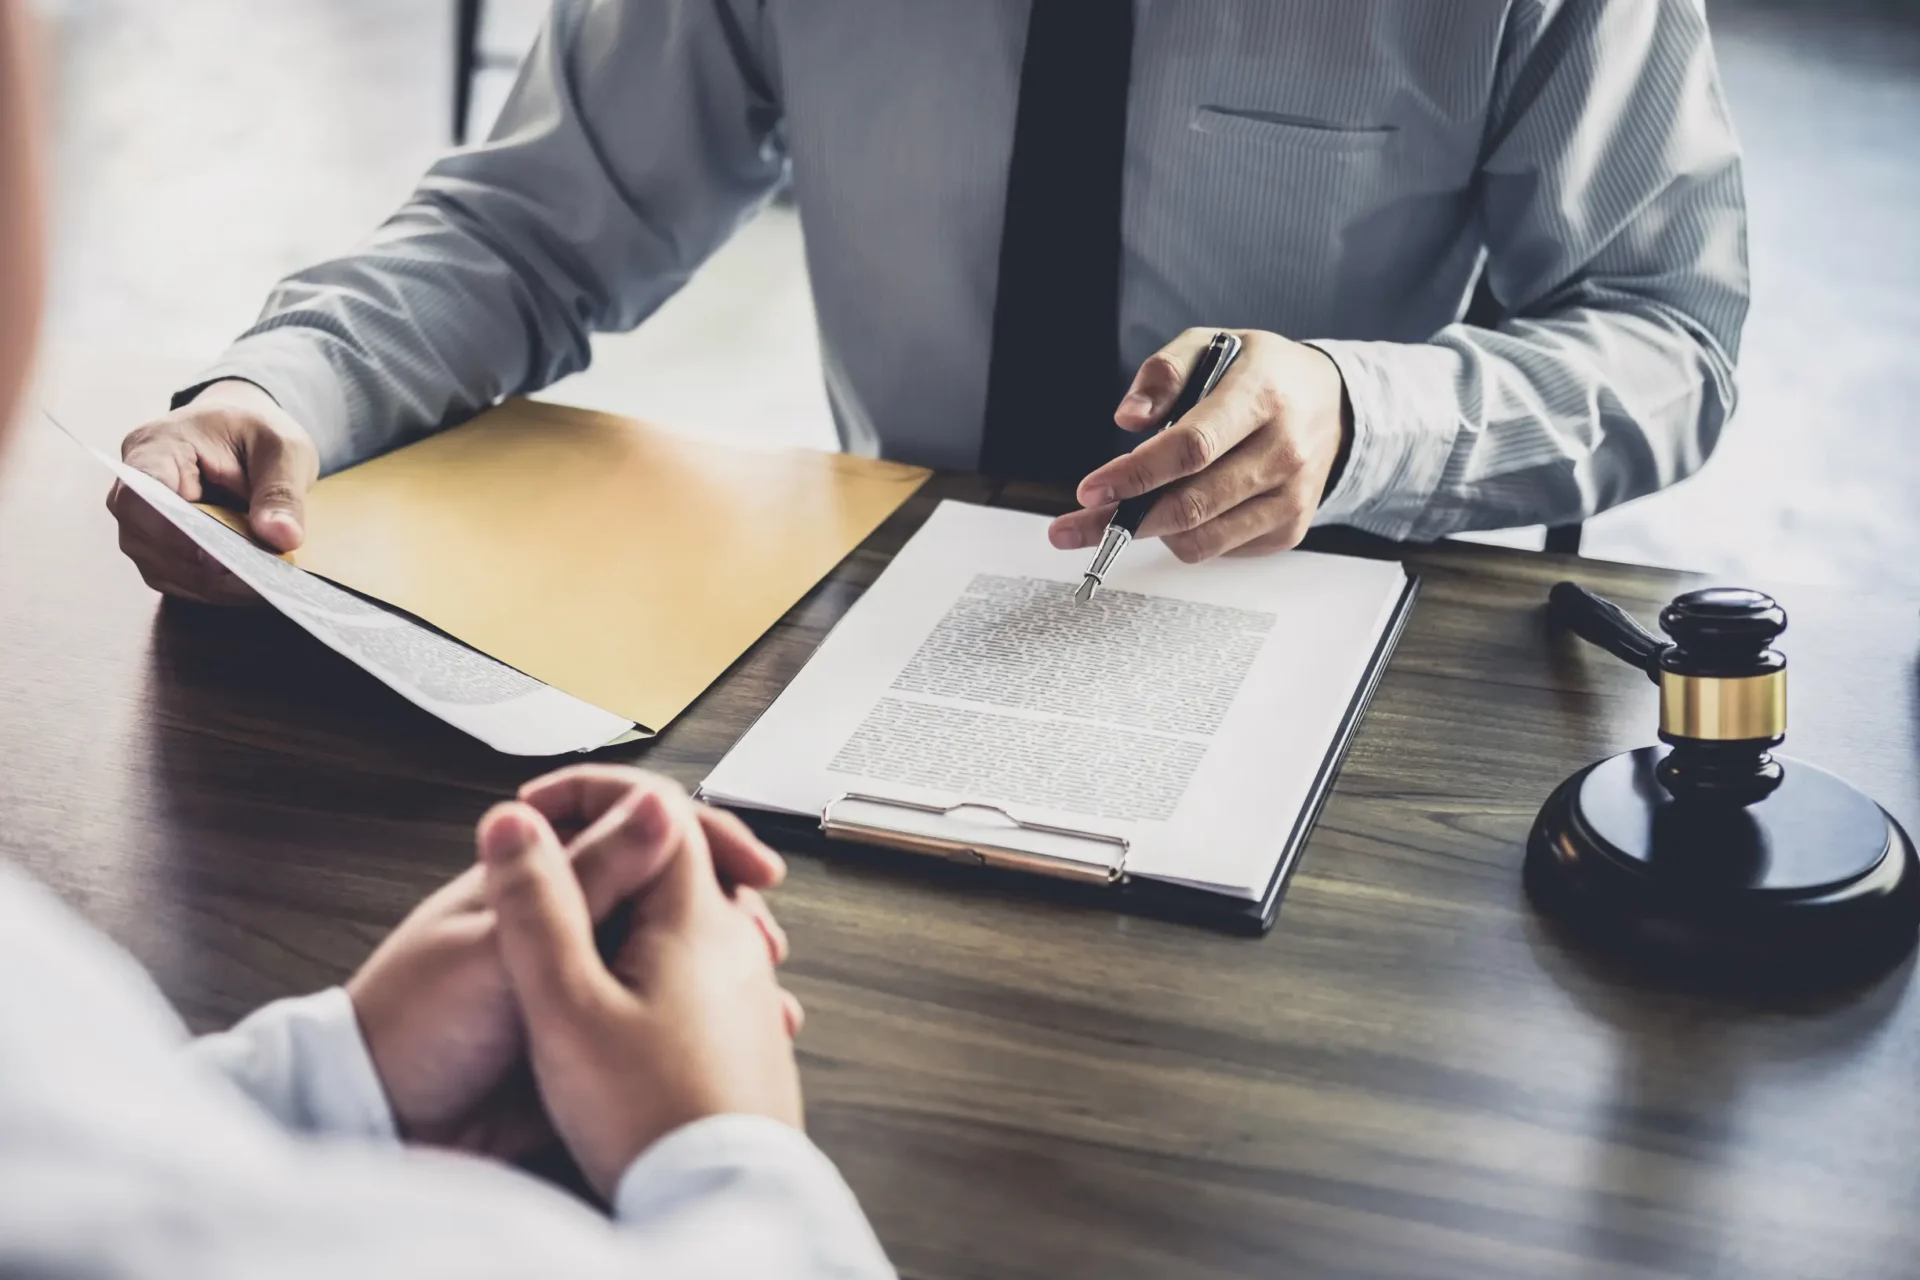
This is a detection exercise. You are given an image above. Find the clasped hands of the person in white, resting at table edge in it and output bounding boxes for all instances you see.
[348,766,801,1196]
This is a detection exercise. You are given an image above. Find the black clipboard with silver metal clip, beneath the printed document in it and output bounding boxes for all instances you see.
[722,574,1421,936]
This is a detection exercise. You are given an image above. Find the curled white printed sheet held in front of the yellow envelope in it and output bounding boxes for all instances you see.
[88,445,634,756]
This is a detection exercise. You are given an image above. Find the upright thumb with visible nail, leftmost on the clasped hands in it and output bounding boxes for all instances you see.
[480,802,612,1031]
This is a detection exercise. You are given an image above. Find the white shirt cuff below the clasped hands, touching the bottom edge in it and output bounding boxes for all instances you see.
[612,1115,895,1280]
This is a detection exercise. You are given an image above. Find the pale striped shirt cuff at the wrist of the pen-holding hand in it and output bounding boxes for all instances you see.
[1306,340,1459,541]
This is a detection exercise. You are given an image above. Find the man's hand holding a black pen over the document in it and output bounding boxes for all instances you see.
[1048,328,1354,564]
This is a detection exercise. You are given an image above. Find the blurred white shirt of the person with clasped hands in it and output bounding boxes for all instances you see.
[0,865,893,1280]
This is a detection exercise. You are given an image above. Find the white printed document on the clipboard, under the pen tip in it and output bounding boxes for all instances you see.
[701,501,1407,900]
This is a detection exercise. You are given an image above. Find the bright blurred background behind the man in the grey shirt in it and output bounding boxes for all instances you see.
[18,0,1920,591]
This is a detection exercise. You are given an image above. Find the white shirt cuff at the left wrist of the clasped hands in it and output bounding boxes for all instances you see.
[186,986,399,1142]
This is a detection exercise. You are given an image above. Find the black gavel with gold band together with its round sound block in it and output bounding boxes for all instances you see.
[1526,581,1920,981]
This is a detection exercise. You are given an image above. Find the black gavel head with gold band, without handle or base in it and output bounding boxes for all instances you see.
[1657,587,1788,804]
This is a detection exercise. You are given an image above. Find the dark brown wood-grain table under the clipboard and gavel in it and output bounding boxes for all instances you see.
[0,422,1920,1278]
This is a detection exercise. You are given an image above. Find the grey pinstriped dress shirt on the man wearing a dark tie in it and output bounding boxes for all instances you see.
[182,0,1747,539]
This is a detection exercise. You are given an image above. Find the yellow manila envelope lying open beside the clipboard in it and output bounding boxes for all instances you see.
[223,399,929,731]
